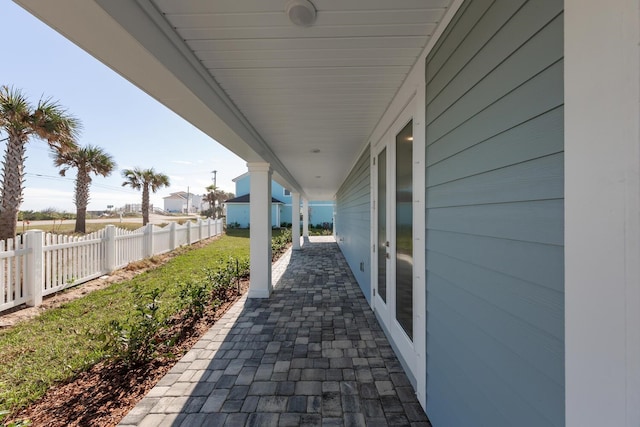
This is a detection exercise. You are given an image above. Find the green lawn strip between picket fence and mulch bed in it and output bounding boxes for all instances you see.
[0,233,249,418]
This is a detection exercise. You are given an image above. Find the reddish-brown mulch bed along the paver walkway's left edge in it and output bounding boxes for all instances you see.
[14,279,249,427]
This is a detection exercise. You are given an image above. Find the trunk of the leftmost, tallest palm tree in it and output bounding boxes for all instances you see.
[0,134,26,240]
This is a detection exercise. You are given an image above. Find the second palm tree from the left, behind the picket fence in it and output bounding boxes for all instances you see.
[53,145,116,233]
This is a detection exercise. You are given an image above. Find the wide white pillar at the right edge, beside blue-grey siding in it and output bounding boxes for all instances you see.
[564,0,640,427]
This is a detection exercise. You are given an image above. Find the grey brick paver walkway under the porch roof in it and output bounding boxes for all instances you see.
[121,237,430,427]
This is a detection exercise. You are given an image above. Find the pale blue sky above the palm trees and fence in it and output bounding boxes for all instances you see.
[0,0,247,212]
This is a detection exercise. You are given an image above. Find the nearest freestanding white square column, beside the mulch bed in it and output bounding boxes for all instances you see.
[247,162,273,298]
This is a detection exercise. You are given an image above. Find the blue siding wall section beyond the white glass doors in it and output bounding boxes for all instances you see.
[335,148,371,303]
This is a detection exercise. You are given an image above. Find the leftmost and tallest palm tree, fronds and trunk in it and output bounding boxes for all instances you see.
[0,86,80,240]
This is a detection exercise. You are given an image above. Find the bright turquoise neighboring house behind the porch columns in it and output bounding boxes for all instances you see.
[225,172,335,228]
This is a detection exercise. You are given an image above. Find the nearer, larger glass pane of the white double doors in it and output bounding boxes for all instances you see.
[396,121,413,340]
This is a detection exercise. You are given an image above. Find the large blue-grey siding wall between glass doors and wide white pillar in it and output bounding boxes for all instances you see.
[426,0,564,427]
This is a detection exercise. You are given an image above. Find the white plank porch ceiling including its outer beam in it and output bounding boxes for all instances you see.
[17,0,452,200]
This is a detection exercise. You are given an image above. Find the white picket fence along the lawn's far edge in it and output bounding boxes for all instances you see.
[0,219,223,313]
